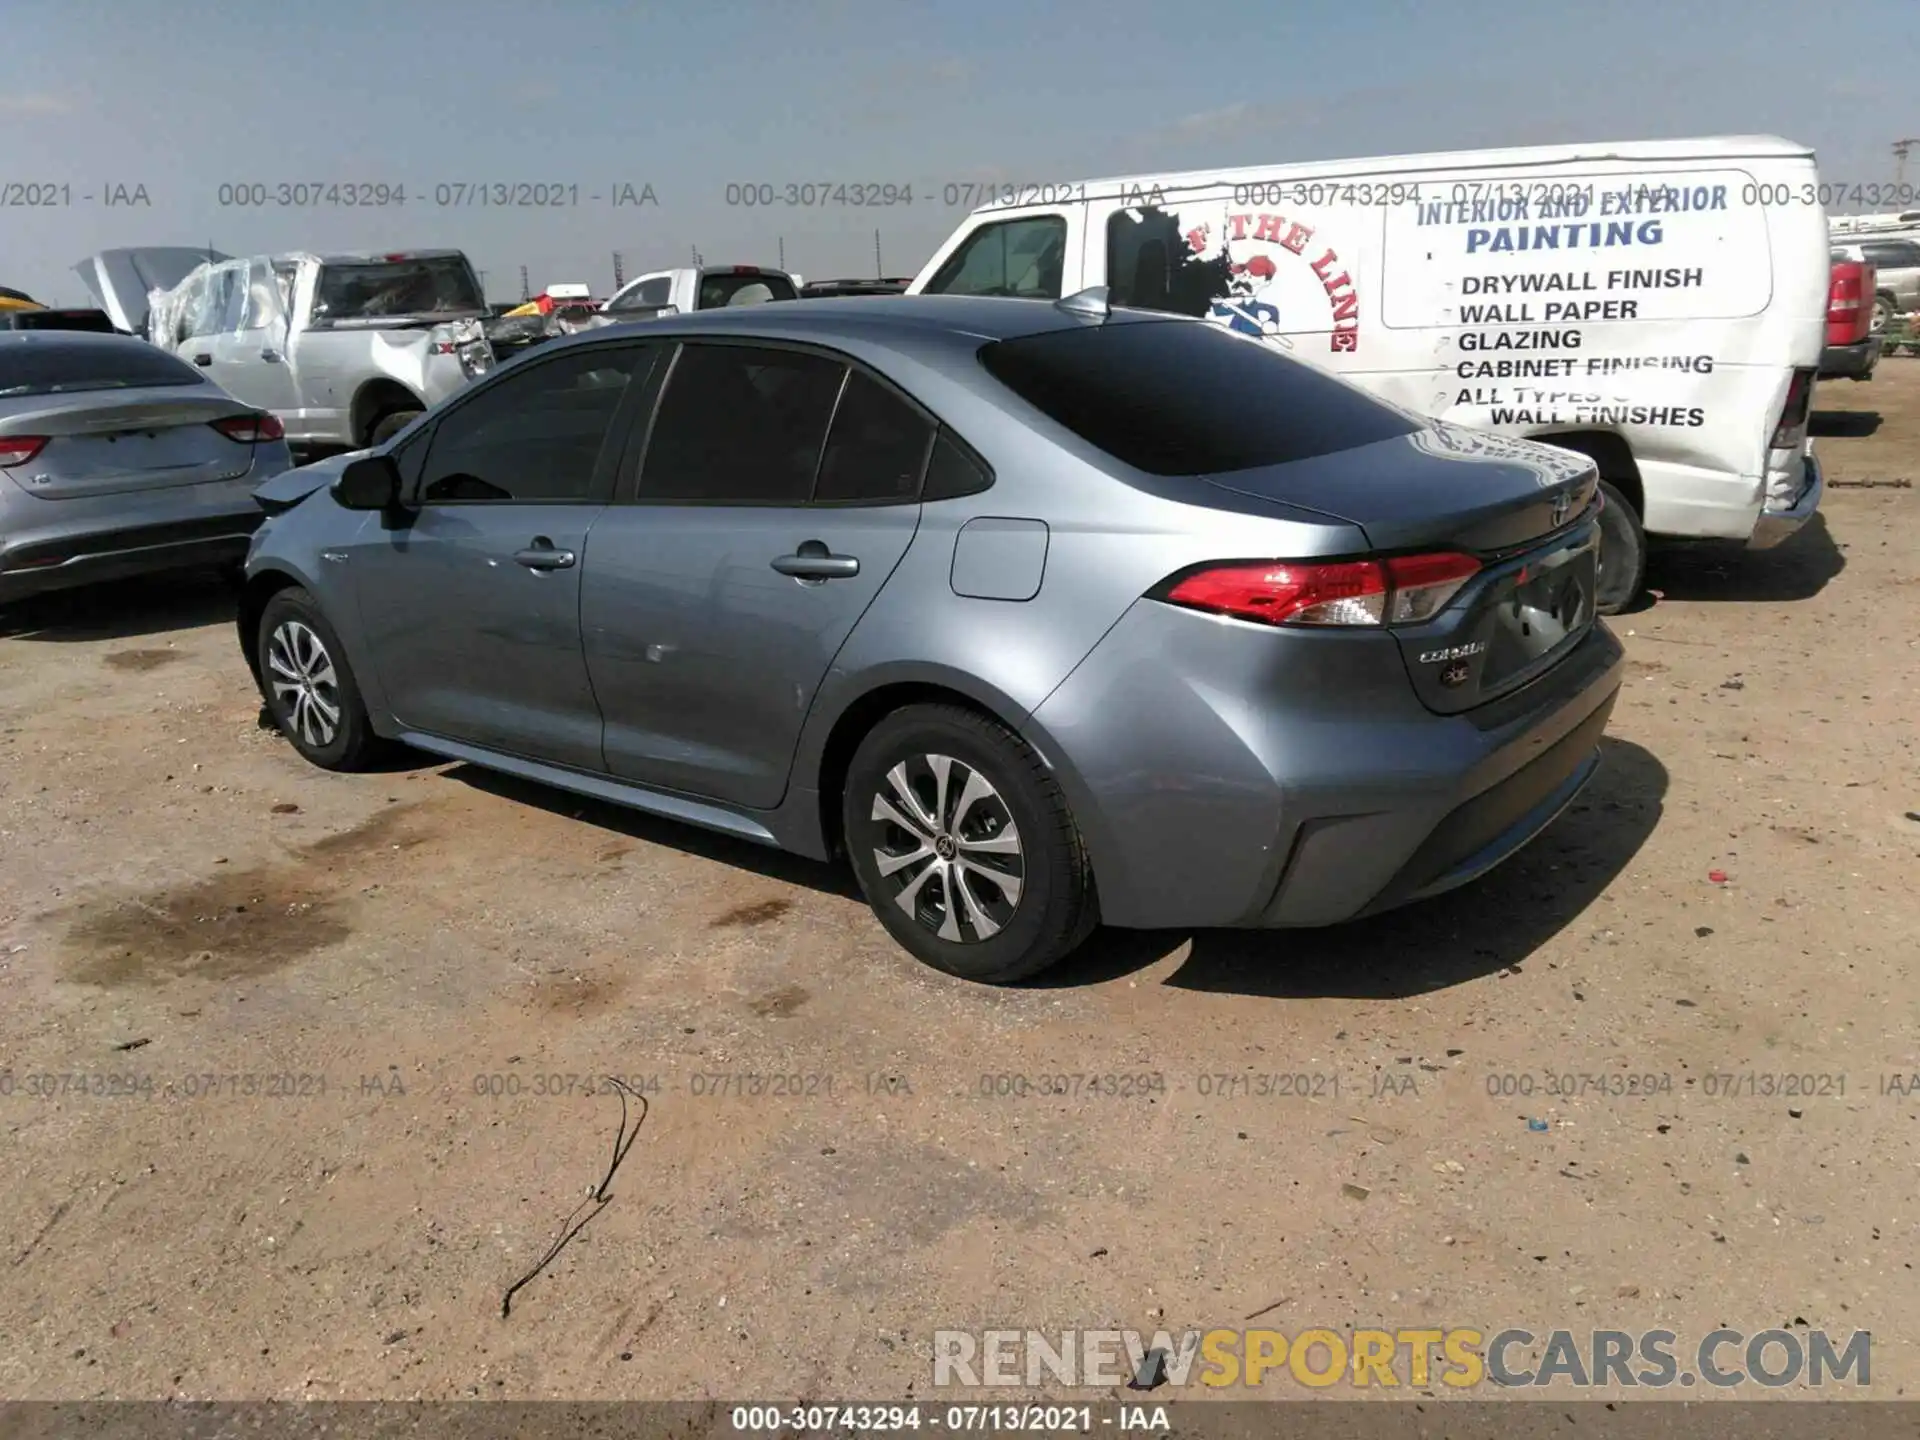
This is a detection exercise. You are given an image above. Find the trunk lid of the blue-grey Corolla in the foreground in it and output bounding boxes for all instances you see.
[1208,426,1599,714]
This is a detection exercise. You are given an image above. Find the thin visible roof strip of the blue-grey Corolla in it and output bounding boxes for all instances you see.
[556,296,1159,344]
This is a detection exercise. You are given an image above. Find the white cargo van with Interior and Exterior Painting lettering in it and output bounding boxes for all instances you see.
[908,136,1828,612]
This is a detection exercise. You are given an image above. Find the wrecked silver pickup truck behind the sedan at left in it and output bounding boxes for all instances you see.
[75,250,493,449]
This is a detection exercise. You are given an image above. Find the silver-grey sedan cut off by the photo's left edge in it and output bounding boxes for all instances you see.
[0,330,294,603]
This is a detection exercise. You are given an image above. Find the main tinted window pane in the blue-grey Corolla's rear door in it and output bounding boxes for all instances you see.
[639,346,847,505]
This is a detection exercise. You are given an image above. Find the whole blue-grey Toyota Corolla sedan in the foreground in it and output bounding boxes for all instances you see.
[238,292,1620,983]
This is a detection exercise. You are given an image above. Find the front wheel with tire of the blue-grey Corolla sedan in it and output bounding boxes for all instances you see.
[253,586,386,772]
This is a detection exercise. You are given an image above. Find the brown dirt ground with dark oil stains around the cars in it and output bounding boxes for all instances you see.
[0,359,1920,1400]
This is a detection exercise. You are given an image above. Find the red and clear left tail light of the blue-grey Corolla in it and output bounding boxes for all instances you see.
[1154,553,1480,626]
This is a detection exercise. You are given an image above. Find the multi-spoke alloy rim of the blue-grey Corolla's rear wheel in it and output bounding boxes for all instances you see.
[872,755,1025,945]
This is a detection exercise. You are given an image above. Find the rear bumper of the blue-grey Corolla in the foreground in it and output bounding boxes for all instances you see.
[1031,601,1622,929]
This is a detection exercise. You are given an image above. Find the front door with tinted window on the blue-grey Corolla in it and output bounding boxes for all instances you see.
[348,344,657,770]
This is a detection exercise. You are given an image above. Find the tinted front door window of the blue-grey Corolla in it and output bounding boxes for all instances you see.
[420,346,653,505]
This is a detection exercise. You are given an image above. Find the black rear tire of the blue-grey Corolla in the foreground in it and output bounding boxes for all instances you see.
[841,705,1098,985]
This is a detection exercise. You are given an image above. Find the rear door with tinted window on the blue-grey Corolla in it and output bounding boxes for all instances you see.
[580,342,935,808]
